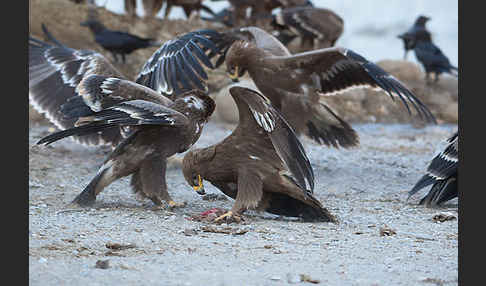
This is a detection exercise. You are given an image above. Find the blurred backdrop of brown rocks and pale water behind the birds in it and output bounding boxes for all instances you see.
[29,0,459,126]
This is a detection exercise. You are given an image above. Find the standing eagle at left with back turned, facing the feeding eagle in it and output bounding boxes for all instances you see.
[37,75,215,206]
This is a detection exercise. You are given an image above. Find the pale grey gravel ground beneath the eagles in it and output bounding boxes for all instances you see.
[29,122,458,286]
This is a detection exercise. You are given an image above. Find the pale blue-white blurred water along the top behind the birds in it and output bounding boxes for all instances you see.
[95,0,459,66]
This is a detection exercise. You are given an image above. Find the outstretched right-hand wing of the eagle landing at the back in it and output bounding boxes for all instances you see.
[267,47,435,123]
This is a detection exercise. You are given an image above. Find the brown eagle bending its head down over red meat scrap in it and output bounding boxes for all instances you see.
[183,86,336,222]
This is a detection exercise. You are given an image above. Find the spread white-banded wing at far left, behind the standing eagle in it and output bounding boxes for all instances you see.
[29,37,124,145]
